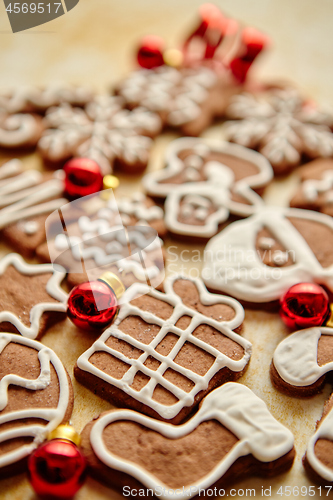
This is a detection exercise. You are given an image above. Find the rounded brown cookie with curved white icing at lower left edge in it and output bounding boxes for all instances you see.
[0,333,73,478]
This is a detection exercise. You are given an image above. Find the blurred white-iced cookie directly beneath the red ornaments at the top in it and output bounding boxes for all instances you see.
[116,66,241,136]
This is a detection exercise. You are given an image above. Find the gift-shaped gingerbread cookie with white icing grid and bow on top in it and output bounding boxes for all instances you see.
[74,276,251,423]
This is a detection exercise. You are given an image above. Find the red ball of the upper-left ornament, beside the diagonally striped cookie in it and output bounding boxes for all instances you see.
[64,158,103,199]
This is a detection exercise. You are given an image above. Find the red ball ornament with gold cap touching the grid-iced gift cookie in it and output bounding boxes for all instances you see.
[67,272,125,332]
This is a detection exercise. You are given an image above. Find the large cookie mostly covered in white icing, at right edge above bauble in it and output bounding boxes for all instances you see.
[202,207,333,305]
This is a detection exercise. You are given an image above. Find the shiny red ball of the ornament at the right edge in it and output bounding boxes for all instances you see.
[280,283,330,330]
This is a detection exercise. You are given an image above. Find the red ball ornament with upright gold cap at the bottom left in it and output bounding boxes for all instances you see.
[28,425,86,500]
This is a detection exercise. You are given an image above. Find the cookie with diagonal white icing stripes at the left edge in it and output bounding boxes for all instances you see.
[0,160,67,258]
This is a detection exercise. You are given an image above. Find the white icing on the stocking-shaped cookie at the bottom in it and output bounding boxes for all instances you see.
[90,382,294,500]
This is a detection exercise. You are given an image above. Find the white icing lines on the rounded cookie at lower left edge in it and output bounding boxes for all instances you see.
[0,333,70,468]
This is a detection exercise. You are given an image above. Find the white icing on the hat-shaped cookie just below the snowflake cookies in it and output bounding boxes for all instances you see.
[143,138,273,238]
